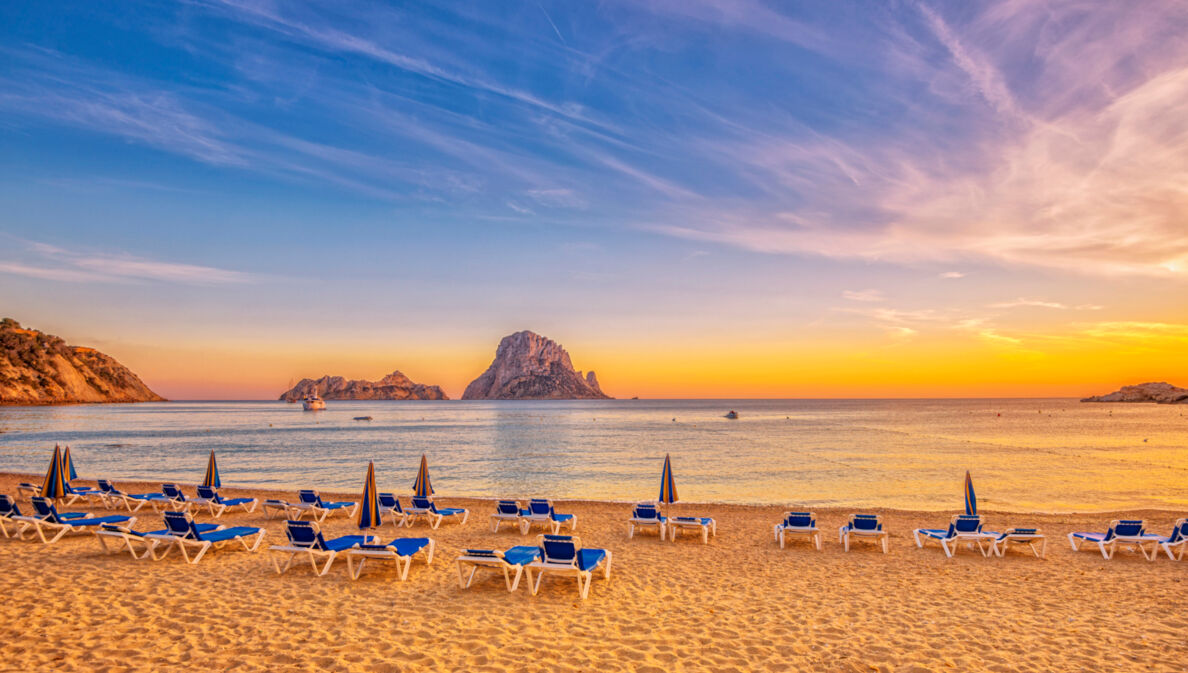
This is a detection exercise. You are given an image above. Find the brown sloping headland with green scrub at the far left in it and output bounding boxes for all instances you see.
[0,317,164,404]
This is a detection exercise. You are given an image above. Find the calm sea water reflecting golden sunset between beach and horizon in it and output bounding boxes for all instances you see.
[0,400,1188,511]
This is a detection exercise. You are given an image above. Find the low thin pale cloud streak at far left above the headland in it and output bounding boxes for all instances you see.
[0,241,259,285]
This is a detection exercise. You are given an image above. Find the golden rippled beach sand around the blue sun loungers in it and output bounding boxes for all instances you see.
[0,474,1188,673]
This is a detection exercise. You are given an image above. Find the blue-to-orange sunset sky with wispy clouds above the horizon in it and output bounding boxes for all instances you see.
[0,0,1188,398]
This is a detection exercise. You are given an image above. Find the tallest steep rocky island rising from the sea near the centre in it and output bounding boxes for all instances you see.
[462,331,611,400]
